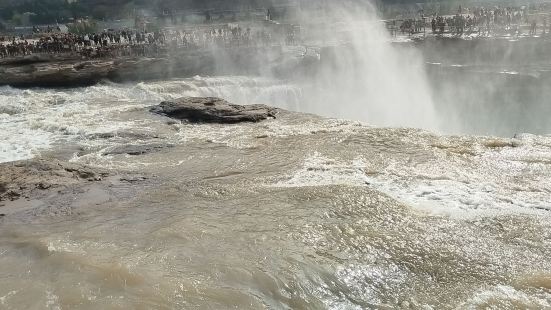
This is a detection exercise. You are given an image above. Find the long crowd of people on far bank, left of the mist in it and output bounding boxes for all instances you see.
[0,26,294,58]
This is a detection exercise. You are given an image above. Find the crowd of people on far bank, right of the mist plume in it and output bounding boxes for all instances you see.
[394,6,551,36]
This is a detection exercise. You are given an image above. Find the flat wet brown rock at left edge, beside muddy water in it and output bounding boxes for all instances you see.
[0,158,156,222]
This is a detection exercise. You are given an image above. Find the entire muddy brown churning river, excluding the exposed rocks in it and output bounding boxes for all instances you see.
[0,77,551,309]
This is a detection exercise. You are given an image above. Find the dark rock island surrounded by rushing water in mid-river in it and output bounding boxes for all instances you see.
[151,97,277,124]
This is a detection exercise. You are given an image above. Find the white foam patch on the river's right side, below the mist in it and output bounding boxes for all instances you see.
[268,137,551,219]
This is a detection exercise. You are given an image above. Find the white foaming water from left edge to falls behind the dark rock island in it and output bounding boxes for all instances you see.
[0,76,301,162]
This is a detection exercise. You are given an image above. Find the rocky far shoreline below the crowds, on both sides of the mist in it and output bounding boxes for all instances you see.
[0,34,551,88]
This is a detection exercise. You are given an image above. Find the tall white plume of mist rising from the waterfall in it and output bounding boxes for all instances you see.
[292,1,438,130]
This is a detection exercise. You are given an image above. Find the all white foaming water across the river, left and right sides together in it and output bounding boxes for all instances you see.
[0,77,551,217]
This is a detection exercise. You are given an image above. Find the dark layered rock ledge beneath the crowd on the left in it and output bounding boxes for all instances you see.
[0,47,296,87]
